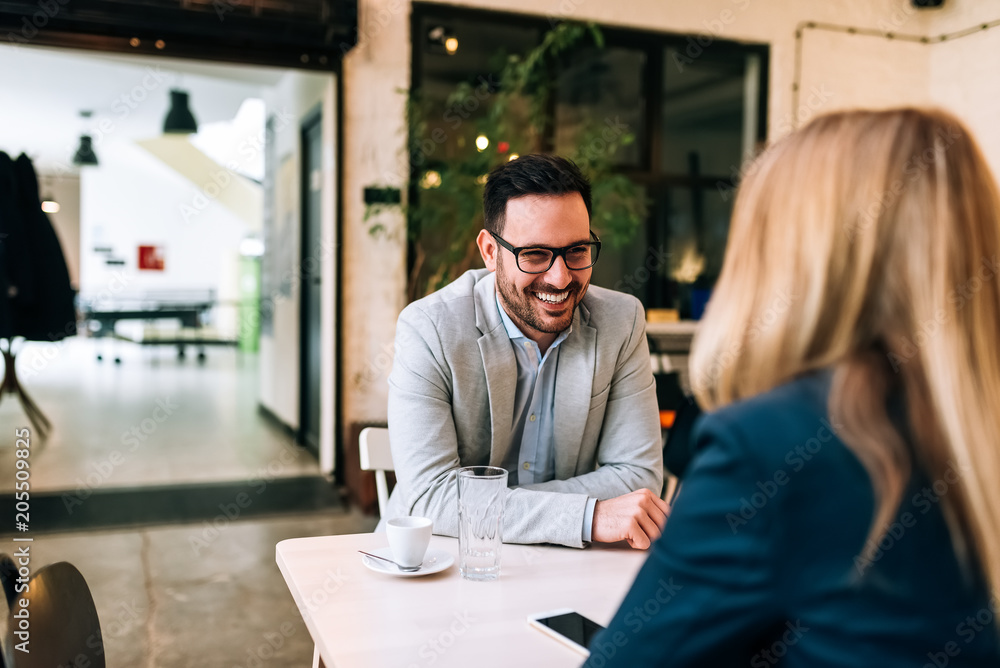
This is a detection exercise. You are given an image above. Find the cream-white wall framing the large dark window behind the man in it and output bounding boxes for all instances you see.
[341,0,1000,433]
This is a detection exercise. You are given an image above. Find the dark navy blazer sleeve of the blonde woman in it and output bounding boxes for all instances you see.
[585,416,794,668]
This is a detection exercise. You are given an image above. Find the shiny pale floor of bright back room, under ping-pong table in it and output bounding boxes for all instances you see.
[0,337,319,493]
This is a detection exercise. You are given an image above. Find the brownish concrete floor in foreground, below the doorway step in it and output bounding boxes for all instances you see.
[0,512,376,668]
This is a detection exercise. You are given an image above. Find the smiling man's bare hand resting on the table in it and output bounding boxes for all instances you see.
[590,489,670,550]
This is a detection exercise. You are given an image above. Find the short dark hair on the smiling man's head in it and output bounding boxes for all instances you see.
[483,153,591,234]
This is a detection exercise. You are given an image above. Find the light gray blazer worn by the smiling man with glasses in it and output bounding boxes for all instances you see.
[386,269,663,547]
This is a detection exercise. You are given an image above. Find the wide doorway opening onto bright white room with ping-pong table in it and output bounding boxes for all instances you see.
[0,45,339,530]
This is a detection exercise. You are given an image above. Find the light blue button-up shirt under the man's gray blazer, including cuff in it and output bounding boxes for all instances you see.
[497,293,597,542]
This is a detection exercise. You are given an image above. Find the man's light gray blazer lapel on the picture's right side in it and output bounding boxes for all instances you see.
[554,305,597,480]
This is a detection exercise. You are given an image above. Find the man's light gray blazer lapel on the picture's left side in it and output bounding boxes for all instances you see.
[475,273,517,466]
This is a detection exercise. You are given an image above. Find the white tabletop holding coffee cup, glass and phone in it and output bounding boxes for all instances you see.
[276,533,646,668]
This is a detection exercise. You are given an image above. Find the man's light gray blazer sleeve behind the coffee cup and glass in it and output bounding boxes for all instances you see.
[389,305,587,547]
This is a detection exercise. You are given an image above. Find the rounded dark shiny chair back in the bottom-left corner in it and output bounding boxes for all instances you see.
[3,561,105,668]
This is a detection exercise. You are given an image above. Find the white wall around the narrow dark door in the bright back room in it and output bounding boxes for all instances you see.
[259,71,336,470]
